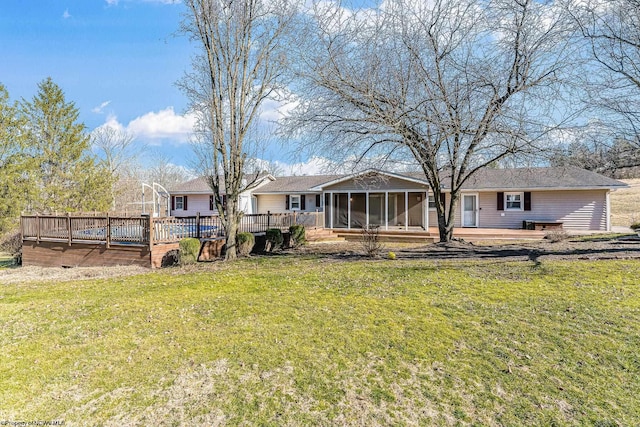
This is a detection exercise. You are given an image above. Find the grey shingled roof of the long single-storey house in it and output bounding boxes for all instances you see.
[170,166,627,194]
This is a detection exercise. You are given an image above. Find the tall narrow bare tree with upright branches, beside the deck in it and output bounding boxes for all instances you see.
[180,0,295,260]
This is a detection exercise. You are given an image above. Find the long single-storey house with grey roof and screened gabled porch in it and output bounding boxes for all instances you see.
[169,167,626,231]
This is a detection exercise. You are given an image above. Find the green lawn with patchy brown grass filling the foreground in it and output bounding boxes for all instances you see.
[0,257,640,426]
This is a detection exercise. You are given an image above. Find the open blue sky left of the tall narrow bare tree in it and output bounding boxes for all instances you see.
[0,0,298,170]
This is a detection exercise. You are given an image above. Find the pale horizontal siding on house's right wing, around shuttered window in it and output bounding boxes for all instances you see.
[478,190,607,230]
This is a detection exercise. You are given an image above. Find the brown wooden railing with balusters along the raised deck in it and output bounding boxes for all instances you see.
[20,212,324,246]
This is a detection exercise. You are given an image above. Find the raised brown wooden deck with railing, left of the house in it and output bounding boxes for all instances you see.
[20,212,322,267]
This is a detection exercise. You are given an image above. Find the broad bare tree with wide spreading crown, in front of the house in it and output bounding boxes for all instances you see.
[288,0,571,241]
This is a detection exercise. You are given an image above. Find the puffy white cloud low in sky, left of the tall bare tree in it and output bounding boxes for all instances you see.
[100,107,196,144]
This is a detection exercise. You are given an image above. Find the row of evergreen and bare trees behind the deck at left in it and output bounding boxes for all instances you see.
[0,78,190,236]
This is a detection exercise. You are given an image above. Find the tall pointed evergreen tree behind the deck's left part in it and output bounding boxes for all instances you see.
[20,78,111,212]
